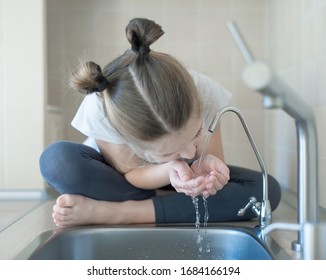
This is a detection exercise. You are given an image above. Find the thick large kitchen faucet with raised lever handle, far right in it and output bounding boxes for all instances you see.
[227,21,320,258]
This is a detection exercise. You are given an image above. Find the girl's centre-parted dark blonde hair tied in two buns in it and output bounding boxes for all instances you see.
[70,18,200,151]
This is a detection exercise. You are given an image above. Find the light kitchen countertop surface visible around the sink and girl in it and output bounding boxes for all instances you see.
[0,196,297,260]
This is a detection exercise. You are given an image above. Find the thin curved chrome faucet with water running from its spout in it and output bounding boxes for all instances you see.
[208,106,272,229]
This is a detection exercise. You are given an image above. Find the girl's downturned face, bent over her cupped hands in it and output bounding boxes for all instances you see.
[145,118,204,163]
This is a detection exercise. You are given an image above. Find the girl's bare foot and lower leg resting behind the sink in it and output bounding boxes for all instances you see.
[52,194,155,228]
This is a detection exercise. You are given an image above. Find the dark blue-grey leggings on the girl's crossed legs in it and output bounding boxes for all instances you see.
[40,141,281,223]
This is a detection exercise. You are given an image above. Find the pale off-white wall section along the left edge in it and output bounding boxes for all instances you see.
[0,0,46,189]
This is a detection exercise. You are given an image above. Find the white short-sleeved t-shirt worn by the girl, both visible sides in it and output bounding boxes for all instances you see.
[71,71,231,150]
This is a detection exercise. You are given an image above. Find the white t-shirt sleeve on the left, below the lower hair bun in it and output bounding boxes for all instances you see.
[71,93,124,144]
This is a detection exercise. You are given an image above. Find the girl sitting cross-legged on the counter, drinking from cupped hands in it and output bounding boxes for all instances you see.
[40,18,281,227]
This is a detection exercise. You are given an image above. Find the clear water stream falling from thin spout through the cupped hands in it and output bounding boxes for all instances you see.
[192,132,212,254]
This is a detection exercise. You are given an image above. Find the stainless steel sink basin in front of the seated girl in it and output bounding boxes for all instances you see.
[17,225,288,260]
